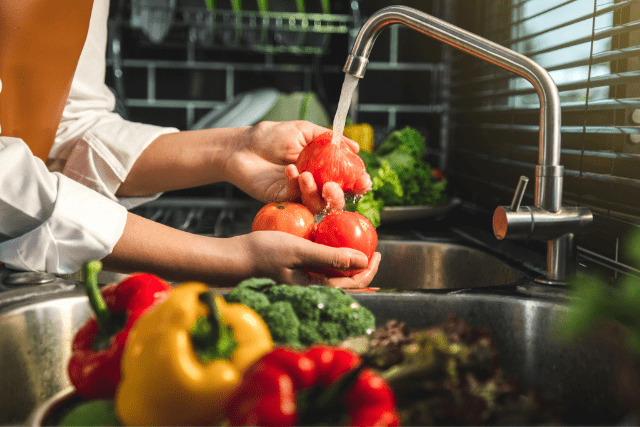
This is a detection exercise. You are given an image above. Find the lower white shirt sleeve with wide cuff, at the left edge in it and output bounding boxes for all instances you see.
[0,137,127,274]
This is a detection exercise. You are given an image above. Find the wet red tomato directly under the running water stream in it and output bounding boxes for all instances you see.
[296,132,366,193]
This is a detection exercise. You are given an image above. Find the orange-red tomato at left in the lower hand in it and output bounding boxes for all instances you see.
[251,202,316,240]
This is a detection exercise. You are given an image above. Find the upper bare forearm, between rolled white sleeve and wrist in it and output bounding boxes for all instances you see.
[116,128,246,197]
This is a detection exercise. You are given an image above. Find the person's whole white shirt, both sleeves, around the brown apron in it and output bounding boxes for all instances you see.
[0,0,178,274]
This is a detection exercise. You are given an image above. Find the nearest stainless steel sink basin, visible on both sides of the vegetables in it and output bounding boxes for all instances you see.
[0,287,626,425]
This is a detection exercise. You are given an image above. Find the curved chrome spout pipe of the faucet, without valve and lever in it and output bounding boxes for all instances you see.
[343,6,563,212]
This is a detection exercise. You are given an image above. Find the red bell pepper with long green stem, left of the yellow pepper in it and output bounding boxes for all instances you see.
[67,261,172,400]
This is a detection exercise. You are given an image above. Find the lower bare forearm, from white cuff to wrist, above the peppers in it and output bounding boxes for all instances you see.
[103,213,252,287]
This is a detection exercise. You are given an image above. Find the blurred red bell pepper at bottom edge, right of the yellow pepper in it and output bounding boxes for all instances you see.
[226,346,400,426]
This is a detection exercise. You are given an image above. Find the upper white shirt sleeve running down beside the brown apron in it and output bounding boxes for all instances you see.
[47,0,178,209]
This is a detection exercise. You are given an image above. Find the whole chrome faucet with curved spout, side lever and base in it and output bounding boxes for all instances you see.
[343,6,593,284]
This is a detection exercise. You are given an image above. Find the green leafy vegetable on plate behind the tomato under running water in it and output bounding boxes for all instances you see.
[346,127,447,227]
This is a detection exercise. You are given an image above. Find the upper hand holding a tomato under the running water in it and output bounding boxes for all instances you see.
[226,120,371,213]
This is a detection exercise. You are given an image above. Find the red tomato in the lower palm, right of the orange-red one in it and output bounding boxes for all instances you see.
[313,211,378,277]
